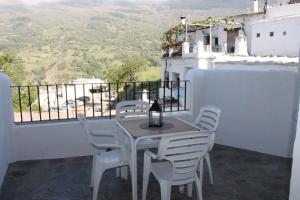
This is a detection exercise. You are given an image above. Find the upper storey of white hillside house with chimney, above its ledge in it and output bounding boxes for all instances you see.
[172,0,300,57]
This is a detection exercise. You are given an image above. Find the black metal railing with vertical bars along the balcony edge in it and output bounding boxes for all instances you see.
[11,80,187,123]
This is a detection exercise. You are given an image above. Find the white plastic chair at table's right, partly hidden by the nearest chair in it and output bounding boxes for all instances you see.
[192,106,222,184]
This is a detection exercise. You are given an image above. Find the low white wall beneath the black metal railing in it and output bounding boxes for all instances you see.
[14,120,115,160]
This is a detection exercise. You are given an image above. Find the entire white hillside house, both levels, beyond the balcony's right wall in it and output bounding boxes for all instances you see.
[160,0,300,99]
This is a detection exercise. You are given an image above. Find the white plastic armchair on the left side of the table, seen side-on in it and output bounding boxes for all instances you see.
[78,113,128,200]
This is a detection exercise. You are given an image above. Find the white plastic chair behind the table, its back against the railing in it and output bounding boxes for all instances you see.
[116,100,158,149]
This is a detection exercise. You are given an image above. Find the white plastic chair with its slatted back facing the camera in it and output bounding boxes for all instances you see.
[142,131,209,200]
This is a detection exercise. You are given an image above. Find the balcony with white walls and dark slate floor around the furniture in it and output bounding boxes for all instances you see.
[0,64,299,200]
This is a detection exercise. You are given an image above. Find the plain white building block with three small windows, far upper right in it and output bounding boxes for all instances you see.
[250,4,300,56]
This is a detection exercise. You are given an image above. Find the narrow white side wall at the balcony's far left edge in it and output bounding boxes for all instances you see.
[0,73,13,187]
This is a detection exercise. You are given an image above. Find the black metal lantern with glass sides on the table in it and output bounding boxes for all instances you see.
[149,100,163,127]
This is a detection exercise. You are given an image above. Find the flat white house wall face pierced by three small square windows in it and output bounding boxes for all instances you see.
[251,16,300,57]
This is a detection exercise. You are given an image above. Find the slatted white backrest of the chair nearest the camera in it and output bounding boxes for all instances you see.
[157,131,209,184]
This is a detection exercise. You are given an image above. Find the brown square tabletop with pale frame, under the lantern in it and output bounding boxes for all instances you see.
[119,117,199,138]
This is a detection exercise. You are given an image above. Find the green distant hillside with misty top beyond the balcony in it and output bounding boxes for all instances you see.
[0,0,262,83]
